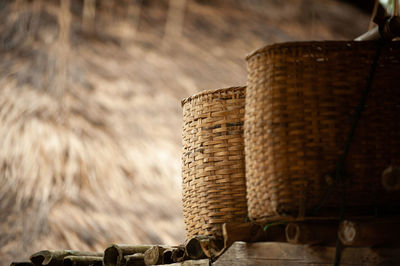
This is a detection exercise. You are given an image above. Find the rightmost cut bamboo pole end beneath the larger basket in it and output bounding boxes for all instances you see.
[338,220,400,247]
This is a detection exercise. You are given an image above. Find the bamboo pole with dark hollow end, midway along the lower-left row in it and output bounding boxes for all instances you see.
[103,244,152,266]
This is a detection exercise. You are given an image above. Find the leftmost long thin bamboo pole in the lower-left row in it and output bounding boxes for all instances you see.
[30,250,103,266]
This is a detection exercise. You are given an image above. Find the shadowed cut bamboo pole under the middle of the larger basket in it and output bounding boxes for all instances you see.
[285,222,338,245]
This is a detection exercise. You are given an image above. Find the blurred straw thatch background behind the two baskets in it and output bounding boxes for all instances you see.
[0,0,374,265]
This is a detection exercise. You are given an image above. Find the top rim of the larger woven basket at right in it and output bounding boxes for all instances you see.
[245,40,395,61]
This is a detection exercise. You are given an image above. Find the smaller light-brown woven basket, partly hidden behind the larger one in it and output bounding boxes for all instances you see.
[182,87,247,238]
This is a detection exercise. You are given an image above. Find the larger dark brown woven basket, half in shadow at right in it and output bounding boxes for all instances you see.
[245,41,400,220]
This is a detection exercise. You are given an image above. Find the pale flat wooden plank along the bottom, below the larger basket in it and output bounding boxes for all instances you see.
[212,242,400,266]
